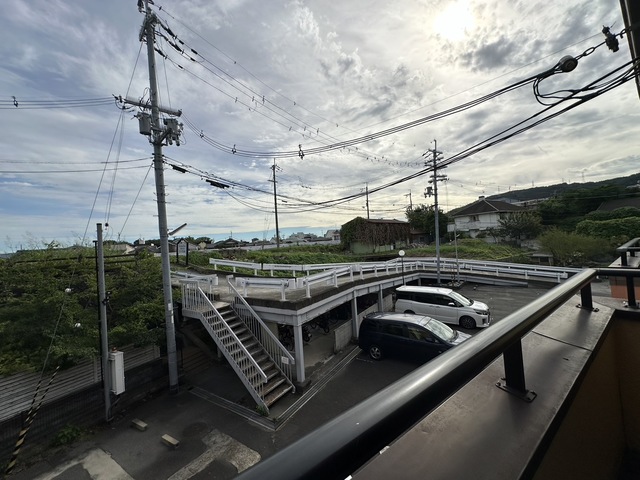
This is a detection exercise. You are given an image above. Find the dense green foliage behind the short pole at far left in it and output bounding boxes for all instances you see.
[0,247,164,374]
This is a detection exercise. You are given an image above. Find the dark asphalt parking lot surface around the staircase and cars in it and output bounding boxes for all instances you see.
[7,285,592,480]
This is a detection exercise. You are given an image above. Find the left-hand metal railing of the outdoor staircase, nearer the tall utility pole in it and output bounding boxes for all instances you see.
[180,280,269,412]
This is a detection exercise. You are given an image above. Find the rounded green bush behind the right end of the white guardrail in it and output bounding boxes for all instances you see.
[538,228,614,266]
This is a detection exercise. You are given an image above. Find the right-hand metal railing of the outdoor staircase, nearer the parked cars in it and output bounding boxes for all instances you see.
[227,275,296,388]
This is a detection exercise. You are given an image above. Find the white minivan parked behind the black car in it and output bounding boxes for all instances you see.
[394,285,491,328]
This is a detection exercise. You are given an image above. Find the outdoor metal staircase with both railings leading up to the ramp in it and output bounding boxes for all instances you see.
[181,280,295,413]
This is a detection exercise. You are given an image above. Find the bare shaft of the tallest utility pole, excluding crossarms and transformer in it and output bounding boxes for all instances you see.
[144,0,179,393]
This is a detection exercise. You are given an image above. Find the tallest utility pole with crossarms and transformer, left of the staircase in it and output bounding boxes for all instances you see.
[129,0,182,393]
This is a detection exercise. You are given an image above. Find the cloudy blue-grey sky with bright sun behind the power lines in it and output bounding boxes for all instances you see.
[0,0,640,252]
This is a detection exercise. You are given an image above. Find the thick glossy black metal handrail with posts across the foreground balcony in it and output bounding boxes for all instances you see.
[237,269,600,480]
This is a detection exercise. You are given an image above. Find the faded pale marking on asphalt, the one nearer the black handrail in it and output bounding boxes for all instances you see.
[167,429,261,480]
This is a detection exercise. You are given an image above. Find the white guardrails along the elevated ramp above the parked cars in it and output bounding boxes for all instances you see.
[210,257,581,301]
